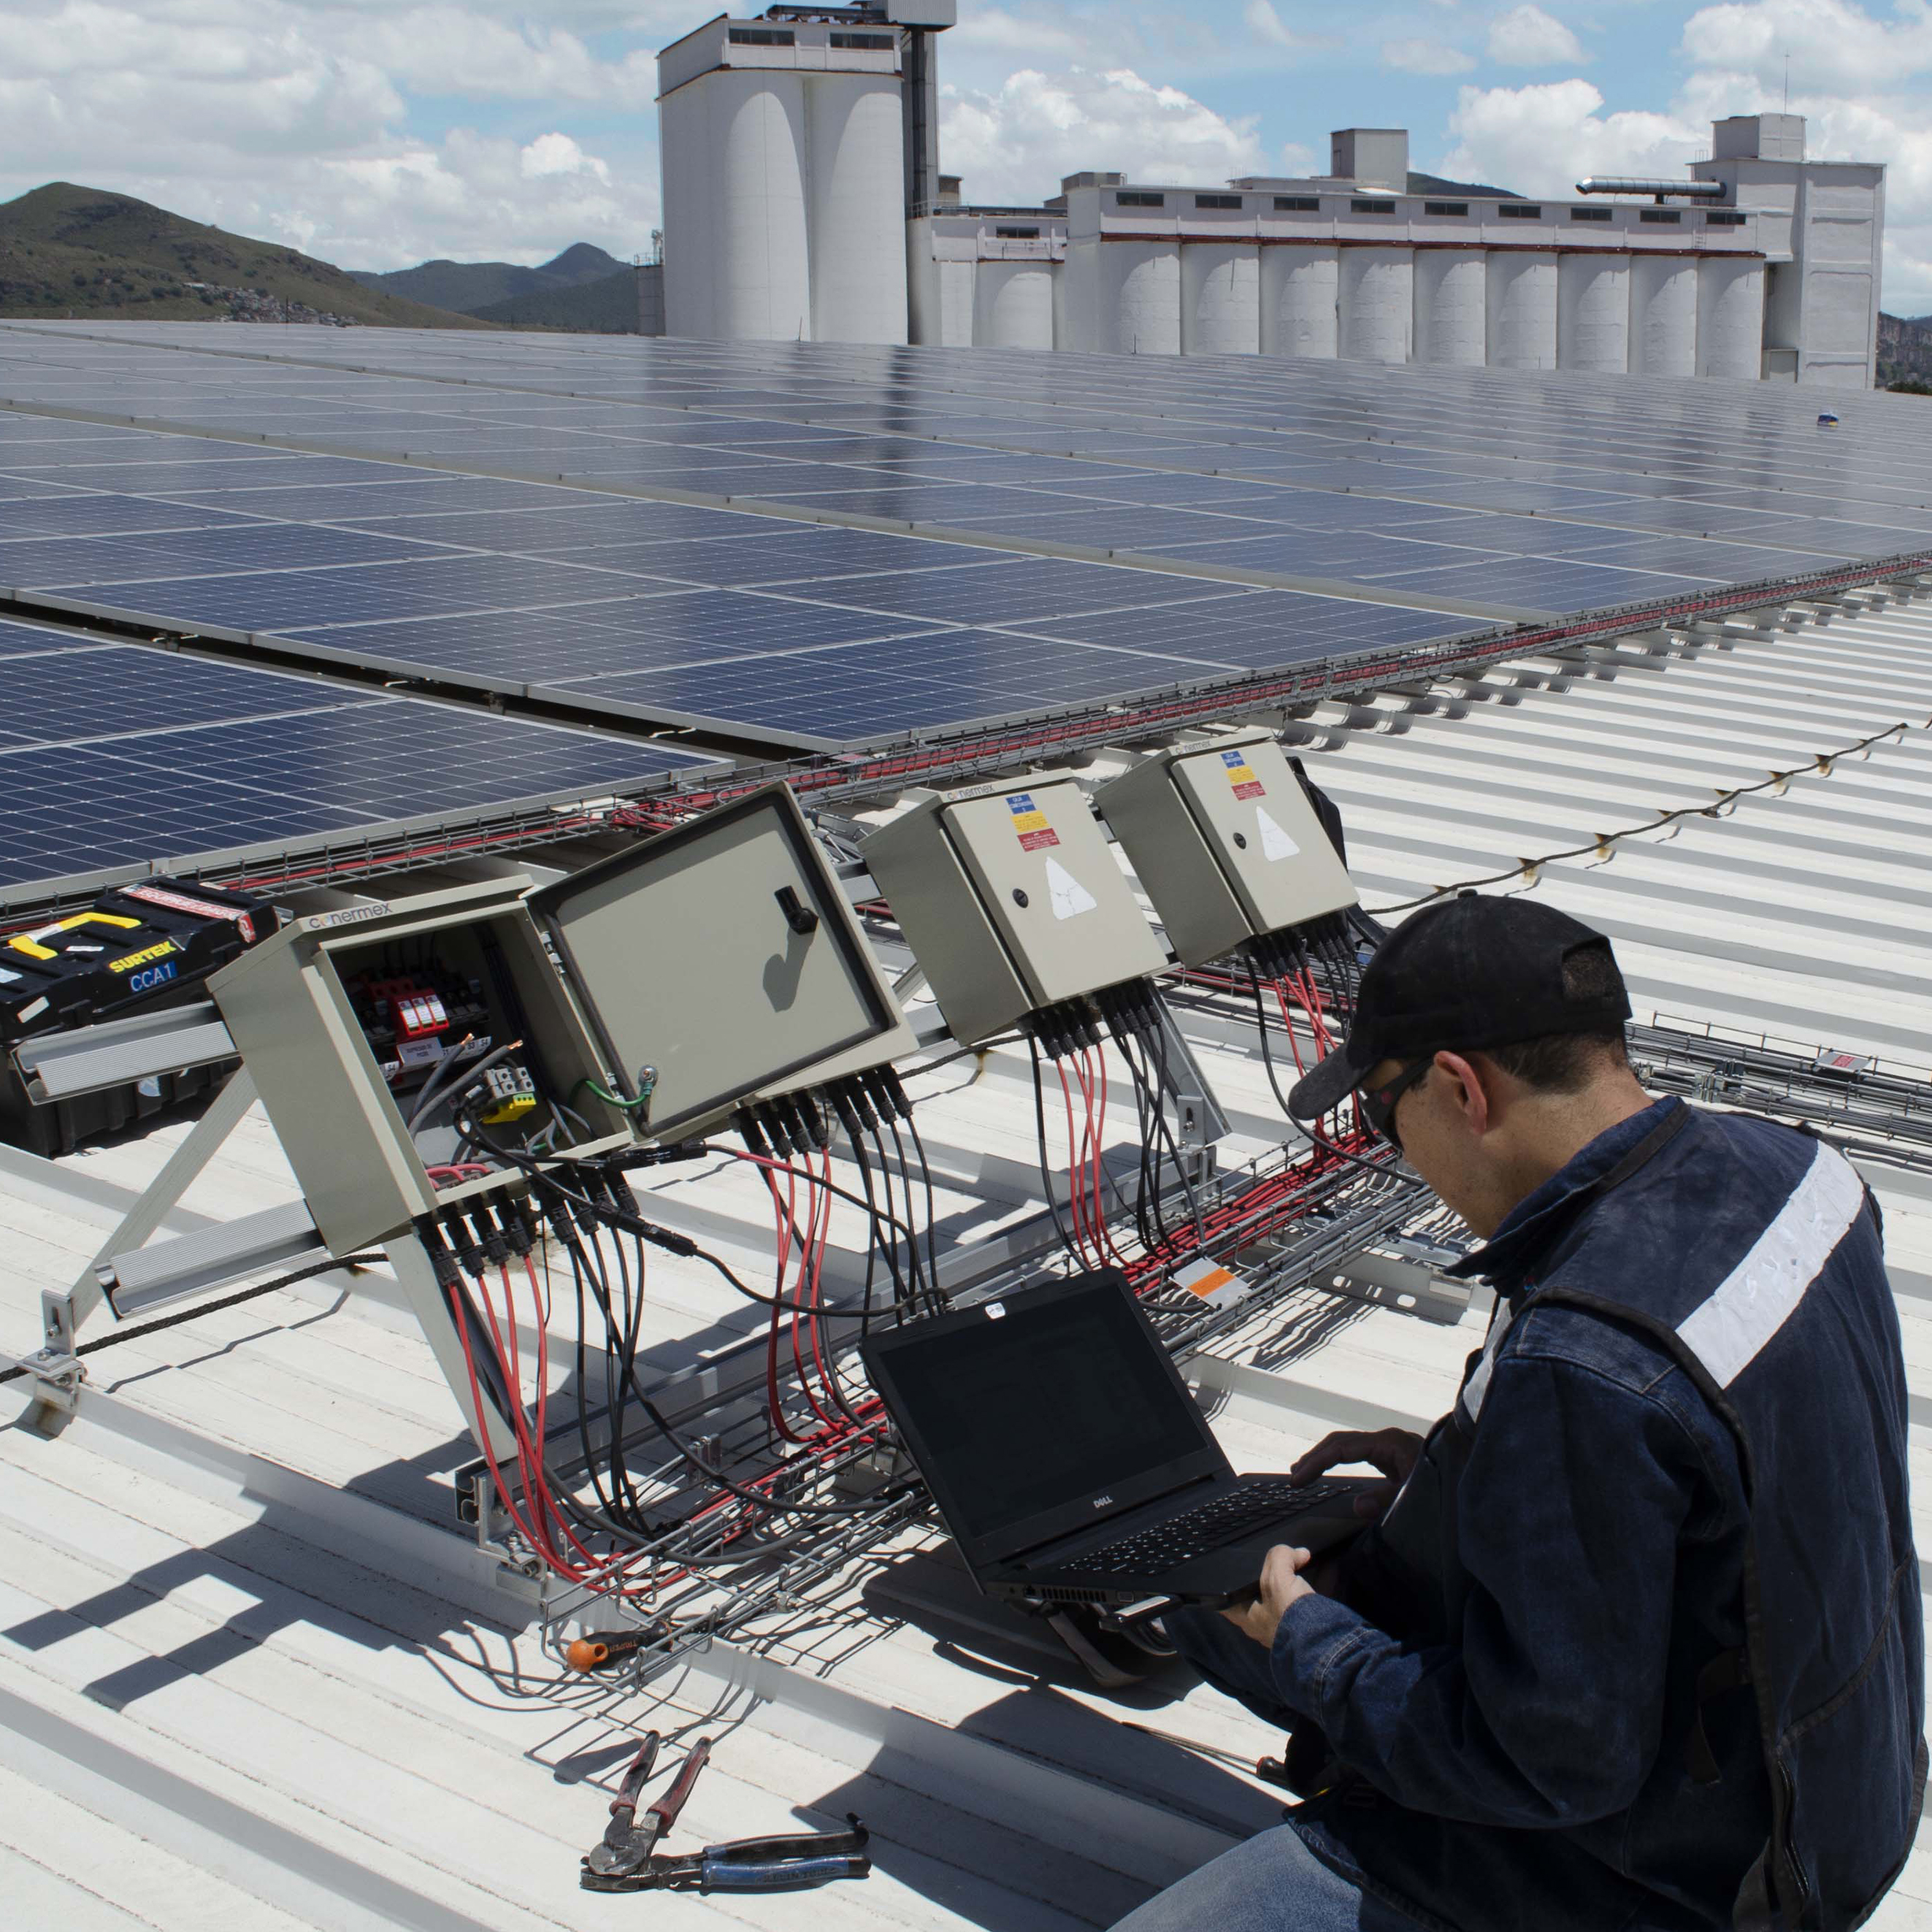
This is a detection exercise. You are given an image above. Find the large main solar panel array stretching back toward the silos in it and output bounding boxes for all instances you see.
[0,325,1932,904]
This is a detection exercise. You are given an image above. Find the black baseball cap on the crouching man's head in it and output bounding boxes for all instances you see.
[1289,892,1630,1121]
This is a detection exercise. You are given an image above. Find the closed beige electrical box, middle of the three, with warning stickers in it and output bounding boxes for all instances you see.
[864,771,1167,1045]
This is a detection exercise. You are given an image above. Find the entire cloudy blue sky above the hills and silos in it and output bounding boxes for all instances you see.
[0,0,1932,315]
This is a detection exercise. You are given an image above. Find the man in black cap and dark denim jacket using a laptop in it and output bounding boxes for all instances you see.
[1122,894,1926,1932]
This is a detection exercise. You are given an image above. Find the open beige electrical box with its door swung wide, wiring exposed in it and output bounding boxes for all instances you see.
[209,786,912,1254]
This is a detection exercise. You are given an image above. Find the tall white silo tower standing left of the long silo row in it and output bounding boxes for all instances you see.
[657,0,954,342]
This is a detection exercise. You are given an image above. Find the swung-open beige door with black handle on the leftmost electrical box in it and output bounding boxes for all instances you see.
[529,784,914,1138]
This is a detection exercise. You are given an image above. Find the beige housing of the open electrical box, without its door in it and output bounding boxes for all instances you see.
[209,879,630,1254]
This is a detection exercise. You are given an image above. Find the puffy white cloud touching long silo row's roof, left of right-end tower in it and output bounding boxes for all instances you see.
[1433,79,1710,195]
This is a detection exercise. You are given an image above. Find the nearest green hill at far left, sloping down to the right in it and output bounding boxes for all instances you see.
[0,182,488,329]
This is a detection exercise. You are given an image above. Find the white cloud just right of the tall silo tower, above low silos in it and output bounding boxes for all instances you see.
[939,68,1268,201]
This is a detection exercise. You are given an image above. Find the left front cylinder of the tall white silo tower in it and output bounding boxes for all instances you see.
[710,68,811,342]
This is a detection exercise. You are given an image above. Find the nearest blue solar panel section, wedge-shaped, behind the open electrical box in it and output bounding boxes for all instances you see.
[0,620,697,906]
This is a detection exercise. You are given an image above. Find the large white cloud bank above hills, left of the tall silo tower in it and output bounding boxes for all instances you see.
[0,0,660,269]
